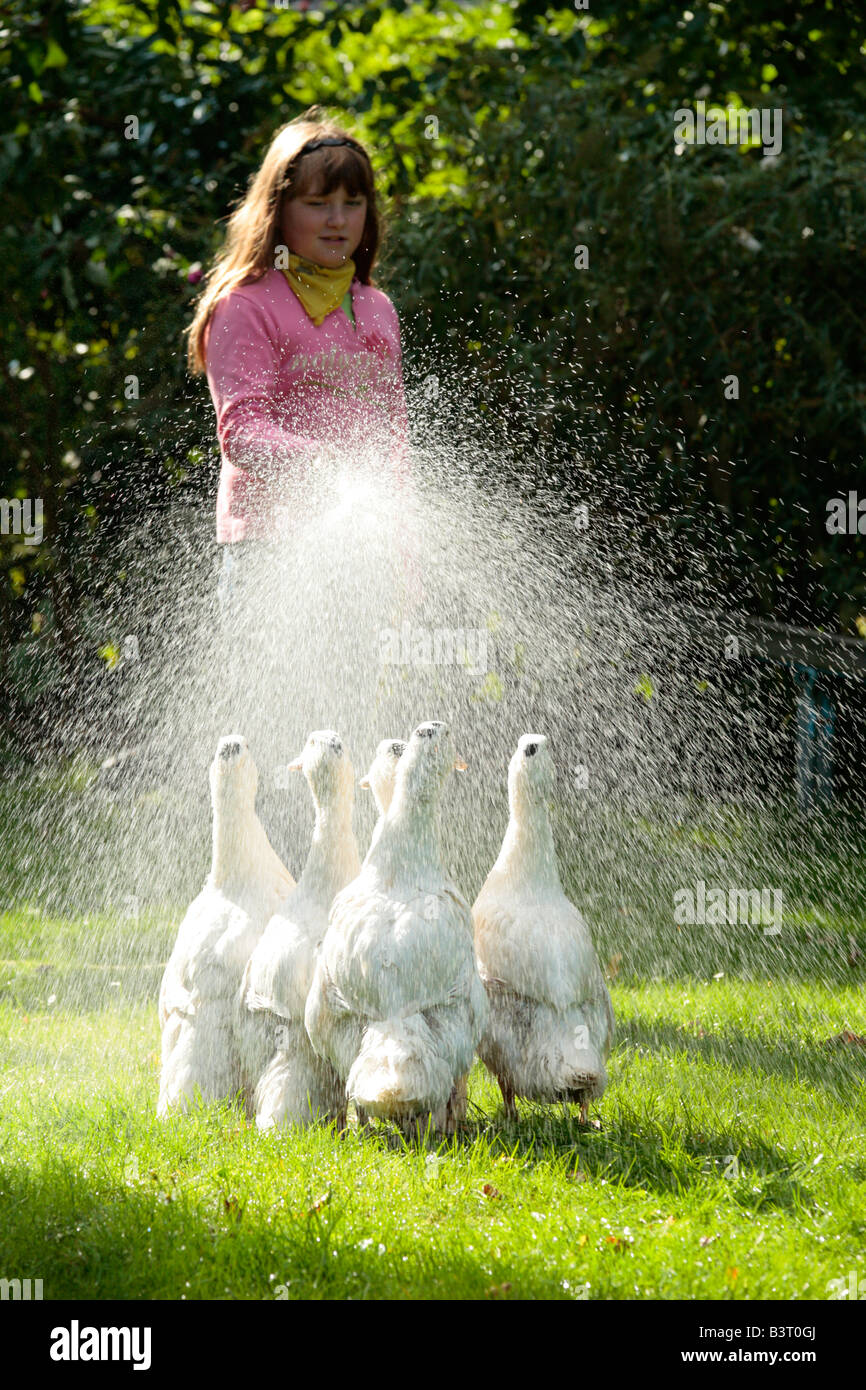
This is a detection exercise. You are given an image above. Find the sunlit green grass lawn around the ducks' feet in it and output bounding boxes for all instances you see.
[0,778,866,1300]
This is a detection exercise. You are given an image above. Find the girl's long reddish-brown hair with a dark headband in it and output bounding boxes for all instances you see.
[186,106,381,374]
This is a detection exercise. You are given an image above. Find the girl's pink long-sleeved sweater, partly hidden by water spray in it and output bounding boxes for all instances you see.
[206,270,409,541]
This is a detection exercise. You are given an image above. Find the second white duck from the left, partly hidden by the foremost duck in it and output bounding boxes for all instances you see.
[235,730,360,1130]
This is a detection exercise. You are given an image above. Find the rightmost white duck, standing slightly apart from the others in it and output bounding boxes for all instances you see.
[473,734,613,1122]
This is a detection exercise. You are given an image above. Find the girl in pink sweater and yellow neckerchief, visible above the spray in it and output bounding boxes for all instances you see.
[189,107,407,589]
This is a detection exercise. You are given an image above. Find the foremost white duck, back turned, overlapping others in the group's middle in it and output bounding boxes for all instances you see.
[306,723,487,1130]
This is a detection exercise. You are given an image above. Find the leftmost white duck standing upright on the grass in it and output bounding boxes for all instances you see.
[157,734,295,1116]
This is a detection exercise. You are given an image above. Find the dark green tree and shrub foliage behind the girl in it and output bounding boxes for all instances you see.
[0,0,866,728]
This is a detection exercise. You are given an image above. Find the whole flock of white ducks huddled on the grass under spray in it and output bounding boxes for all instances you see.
[158,723,613,1133]
